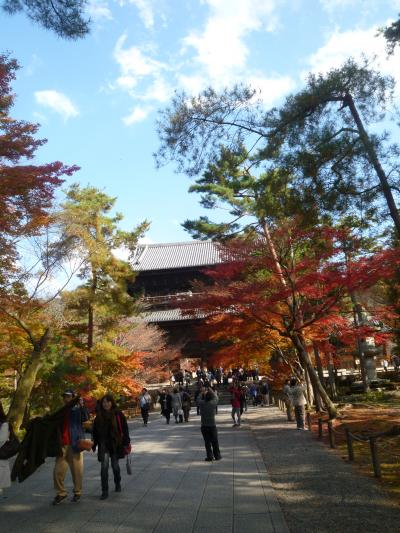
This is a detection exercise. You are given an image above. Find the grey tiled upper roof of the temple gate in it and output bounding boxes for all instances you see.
[132,241,223,272]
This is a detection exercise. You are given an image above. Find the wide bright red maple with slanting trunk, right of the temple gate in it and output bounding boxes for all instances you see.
[187,227,400,417]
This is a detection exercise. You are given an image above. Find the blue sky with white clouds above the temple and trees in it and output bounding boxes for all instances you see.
[0,0,400,242]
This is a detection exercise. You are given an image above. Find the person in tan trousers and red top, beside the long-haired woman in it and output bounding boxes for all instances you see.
[53,390,84,505]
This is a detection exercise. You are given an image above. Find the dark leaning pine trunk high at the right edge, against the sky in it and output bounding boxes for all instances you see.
[344,93,400,237]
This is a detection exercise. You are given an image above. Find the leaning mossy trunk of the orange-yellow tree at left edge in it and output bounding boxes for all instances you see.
[7,329,49,431]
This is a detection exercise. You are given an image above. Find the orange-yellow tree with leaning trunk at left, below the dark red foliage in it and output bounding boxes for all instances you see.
[0,226,80,429]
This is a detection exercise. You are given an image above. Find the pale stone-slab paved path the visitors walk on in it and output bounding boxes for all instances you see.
[0,408,289,533]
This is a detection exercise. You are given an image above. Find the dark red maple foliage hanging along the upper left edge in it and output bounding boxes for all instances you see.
[0,55,78,290]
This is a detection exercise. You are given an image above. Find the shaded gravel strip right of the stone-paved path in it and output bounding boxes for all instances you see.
[246,407,400,533]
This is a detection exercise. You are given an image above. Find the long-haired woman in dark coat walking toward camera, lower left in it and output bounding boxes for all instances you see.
[93,394,131,500]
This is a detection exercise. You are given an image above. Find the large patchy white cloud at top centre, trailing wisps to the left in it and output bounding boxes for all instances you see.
[111,0,295,125]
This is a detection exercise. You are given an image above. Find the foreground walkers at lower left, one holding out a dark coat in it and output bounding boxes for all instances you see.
[0,390,131,505]
